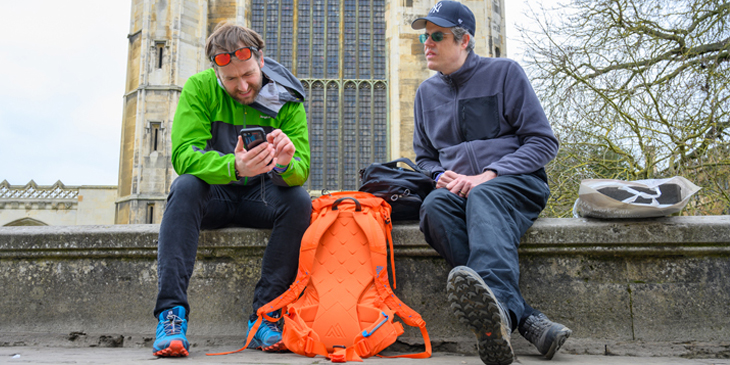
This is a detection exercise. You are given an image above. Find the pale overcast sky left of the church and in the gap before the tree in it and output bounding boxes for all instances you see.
[0,0,548,185]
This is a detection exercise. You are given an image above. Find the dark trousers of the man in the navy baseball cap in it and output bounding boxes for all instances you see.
[420,174,550,330]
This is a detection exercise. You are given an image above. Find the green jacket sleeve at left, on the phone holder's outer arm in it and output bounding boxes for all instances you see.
[171,78,236,184]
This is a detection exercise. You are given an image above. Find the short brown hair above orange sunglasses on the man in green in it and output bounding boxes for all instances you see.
[205,22,264,64]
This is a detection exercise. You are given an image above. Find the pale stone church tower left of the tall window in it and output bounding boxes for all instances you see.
[115,0,246,224]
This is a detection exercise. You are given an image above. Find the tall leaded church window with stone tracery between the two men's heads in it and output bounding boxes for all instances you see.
[251,0,388,191]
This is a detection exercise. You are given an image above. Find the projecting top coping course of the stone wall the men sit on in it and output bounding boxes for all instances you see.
[5,216,730,258]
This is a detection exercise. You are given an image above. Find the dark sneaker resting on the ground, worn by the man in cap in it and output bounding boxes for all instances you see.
[519,313,573,360]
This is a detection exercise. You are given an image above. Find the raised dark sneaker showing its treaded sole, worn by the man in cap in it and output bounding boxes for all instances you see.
[446,266,515,365]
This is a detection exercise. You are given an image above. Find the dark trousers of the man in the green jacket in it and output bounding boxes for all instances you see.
[154,175,312,318]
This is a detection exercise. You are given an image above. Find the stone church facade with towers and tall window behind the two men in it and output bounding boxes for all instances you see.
[115,0,507,224]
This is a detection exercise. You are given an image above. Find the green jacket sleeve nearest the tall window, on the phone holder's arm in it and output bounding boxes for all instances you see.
[269,102,309,186]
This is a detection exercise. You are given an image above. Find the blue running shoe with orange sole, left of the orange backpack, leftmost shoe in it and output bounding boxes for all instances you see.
[152,306,190,357]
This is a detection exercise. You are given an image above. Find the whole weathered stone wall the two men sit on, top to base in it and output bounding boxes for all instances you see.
[0,216,730,356]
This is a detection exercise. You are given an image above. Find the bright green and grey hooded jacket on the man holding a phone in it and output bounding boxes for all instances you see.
[172,58,309,186]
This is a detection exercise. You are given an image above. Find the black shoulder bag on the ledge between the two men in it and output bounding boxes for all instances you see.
[358,158,434,221]
